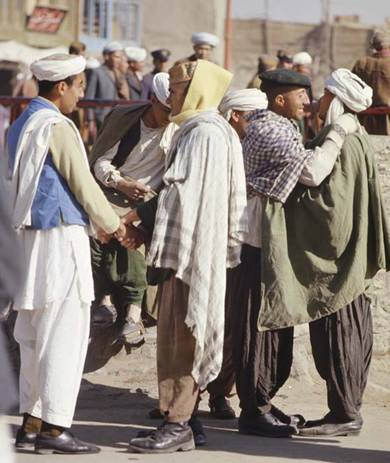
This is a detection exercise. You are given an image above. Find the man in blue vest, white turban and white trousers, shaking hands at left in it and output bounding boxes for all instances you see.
[7,54,126,454]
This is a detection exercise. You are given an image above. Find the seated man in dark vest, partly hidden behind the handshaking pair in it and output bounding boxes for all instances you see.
[90,72,175,345]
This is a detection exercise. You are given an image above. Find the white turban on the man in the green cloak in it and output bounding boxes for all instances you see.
[325,68,373,129]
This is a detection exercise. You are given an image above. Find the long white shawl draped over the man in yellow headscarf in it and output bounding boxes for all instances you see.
[147,110,247,388]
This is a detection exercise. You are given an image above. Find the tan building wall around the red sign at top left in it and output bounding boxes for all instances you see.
[0,0,79,48]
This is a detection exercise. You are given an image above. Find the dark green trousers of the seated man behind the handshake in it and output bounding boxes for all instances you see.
[91,238,147,321]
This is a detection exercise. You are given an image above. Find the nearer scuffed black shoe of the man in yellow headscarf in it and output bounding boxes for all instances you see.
[130,422,195,453]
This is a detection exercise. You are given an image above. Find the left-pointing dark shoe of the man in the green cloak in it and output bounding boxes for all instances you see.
[299,413,363,437]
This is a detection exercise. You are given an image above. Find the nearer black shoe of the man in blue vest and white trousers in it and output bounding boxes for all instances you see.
[35,431,100,455]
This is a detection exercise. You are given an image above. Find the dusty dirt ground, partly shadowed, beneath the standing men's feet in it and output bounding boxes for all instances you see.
[9,329,390,463]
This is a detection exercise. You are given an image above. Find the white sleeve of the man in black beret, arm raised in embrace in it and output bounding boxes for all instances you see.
[299,130,344,186]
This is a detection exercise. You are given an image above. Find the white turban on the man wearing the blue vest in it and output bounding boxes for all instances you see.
[30,53,86,82]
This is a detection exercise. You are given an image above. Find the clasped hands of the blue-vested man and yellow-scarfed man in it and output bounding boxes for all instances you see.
[97,210,146,249]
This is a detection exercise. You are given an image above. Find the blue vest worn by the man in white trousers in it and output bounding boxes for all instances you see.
[7,97,89,230]
